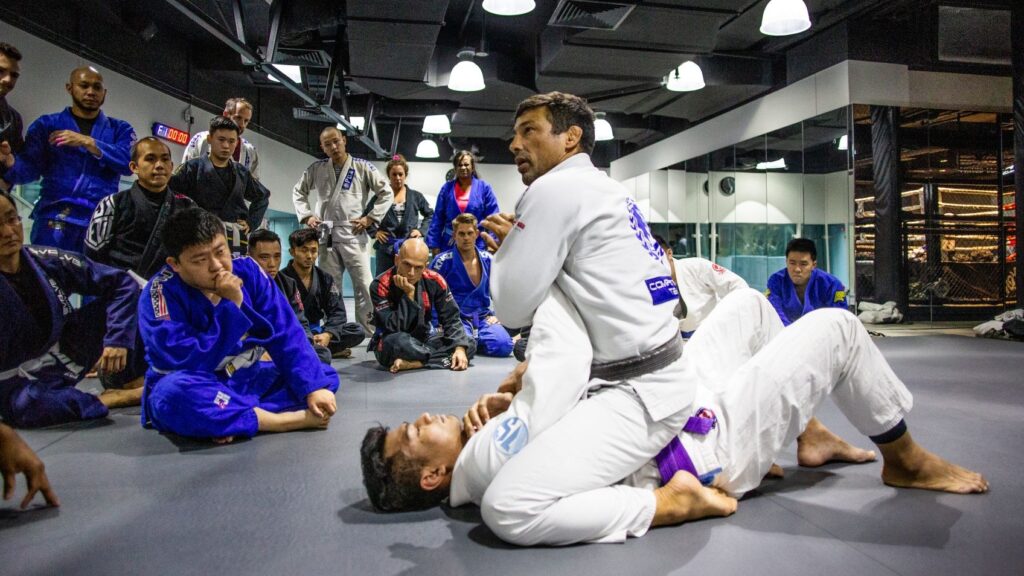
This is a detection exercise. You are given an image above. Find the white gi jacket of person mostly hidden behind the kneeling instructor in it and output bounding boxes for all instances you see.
[675,258,750,332]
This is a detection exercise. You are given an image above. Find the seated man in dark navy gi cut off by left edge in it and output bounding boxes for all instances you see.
[0,192,145,427]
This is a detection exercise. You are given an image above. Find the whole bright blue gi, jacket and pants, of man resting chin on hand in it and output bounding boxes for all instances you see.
[138,253,338,438]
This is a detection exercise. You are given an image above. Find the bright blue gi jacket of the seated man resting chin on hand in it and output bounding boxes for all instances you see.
[138,256,331,403]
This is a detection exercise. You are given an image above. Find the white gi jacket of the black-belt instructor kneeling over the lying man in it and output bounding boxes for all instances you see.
[490,153,693,421]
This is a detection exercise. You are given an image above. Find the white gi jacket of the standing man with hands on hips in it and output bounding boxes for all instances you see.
[292,154,394,244]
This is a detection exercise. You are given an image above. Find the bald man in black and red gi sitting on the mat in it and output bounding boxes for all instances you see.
[369,238,476,373]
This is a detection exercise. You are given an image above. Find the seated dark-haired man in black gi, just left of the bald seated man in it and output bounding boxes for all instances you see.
[281,228,367,358]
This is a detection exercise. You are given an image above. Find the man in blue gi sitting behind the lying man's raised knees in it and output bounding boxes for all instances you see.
[765,238,847,326]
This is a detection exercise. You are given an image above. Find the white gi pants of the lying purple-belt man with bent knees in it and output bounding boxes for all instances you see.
[682,290,913,497]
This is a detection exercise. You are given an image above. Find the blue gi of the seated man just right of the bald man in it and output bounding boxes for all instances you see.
[430,248,513,358]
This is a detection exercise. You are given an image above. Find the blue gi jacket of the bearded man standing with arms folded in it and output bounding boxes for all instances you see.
[3,108,135,228]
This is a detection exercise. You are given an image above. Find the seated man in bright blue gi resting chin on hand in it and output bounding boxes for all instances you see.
[138,204,338,444]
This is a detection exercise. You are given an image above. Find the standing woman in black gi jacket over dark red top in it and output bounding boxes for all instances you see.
[362,154,434,276]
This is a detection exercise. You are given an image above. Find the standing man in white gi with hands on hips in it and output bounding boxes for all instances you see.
[292,126,394,334]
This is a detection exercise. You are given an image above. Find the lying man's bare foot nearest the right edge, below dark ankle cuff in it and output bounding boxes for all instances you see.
[879,433,988,494]
